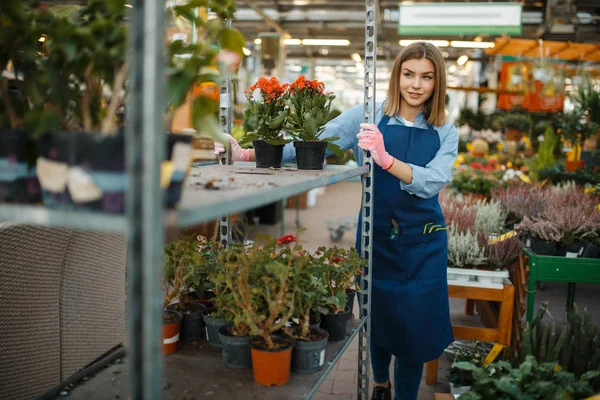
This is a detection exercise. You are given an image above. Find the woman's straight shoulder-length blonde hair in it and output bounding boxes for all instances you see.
[383,42,446,126]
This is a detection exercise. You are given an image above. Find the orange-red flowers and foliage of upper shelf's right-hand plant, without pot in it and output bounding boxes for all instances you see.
[285,75,342,156]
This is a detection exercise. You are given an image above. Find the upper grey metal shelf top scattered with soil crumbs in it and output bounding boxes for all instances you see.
[169,163,367,227]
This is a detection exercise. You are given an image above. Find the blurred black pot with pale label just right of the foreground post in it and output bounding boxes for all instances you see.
[165,133,193,208]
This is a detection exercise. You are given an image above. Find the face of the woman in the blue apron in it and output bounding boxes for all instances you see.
[400,58,435,108]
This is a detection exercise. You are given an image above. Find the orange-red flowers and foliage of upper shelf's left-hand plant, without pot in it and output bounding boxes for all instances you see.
[240,77,289,145]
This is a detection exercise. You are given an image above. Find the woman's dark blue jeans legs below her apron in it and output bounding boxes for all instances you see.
[371,342,423,400]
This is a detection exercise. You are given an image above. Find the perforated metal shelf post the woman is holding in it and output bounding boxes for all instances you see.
[357,0,379,400]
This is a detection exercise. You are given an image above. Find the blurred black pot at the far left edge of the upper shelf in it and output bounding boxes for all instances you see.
[0,129,42,203]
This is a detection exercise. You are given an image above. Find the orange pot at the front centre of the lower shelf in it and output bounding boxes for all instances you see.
[250,337,294,386]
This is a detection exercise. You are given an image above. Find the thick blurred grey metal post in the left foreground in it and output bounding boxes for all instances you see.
[126,0,165,400]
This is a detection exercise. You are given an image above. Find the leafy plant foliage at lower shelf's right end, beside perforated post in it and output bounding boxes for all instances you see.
[315,246,365,314]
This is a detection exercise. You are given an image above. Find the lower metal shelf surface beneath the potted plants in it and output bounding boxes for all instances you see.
[63,319,364,400]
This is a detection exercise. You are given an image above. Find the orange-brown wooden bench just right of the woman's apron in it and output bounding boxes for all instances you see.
[425,282,515,385]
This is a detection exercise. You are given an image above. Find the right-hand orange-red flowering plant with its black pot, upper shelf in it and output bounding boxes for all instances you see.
[285,75,343,169]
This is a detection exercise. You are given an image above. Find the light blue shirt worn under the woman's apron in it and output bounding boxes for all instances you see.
[283,103,458,199]
